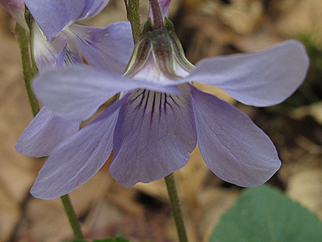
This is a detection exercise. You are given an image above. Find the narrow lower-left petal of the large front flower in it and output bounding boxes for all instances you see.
[30,97,122,199]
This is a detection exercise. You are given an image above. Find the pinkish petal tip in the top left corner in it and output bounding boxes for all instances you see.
[0,0,28,30]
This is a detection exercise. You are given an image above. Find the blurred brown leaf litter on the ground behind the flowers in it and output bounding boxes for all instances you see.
[0,0,322,242]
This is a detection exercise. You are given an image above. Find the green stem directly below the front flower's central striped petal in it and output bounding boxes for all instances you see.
[164,173,188,242]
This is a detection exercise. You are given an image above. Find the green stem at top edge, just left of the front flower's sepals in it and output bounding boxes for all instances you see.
[125,0,142,43]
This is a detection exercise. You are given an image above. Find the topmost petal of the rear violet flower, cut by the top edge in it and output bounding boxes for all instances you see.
[25,0,109,41]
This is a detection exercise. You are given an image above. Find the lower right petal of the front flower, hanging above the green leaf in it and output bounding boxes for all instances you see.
[191,87,281,187]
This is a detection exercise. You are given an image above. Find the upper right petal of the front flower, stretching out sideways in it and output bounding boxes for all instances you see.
[185,40,309,106]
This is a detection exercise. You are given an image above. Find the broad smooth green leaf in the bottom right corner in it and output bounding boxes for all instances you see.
[209,185,322,242]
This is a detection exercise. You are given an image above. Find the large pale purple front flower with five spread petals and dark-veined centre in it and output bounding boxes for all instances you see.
[31,19,309,199]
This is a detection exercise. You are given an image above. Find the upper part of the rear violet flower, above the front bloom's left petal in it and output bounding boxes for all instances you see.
[25,0,133,74]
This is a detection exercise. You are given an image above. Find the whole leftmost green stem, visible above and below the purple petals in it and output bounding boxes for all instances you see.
[17,24,84,239]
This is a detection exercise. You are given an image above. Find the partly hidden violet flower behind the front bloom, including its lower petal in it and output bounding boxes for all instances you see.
[16,0,133,157]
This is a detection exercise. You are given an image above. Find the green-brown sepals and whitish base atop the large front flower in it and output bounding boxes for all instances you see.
[124,18,195,84]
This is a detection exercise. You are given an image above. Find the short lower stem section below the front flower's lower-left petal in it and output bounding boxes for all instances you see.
[60,194,84,239]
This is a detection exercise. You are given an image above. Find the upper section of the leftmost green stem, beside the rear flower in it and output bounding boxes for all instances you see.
[17,24,40,116]
